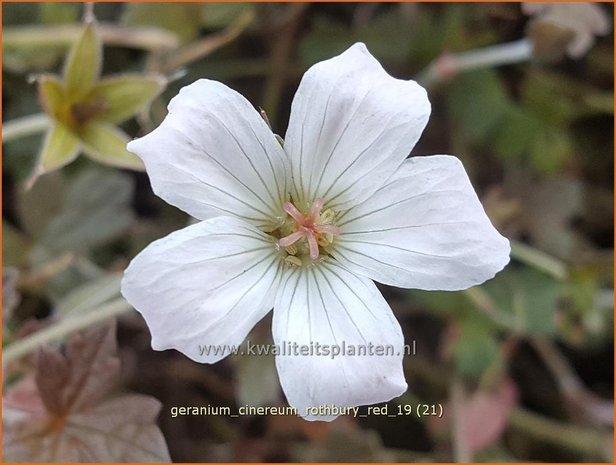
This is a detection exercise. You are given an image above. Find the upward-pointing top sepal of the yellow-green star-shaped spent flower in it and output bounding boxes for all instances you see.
[64,23,103,101]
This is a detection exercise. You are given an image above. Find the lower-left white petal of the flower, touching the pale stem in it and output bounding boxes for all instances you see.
[122,217,280,363]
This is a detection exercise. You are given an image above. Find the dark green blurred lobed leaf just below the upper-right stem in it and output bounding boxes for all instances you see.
[449,66,576,173]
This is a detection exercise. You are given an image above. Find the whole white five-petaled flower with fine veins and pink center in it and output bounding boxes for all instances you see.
[122,44,509,420]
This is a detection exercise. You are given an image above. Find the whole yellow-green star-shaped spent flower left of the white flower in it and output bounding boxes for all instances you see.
[34,21,166,178]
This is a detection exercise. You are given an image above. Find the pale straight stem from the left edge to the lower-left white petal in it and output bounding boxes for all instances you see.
[2,298,133,366]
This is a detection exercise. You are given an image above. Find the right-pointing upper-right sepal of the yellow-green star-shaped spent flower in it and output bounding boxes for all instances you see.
[90,74,167,123]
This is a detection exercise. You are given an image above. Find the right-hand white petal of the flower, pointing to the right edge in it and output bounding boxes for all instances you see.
[333,155,510,290]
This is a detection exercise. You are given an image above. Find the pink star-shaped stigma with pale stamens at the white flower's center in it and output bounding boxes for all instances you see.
[278,199,340,266]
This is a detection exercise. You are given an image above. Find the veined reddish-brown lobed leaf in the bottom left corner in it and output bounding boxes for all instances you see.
[2,325,170,462]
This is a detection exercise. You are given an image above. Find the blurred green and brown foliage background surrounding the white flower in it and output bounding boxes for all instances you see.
[2,3,614,462]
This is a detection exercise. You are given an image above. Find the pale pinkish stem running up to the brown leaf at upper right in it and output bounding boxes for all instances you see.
[417,38,533,87]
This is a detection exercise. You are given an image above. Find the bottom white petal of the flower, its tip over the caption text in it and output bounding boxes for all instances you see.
[273,262,406,420]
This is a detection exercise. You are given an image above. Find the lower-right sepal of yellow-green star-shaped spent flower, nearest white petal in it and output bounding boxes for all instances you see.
[79,122,144,171]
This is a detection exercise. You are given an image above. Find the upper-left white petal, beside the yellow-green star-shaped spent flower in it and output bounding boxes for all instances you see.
[128,79,287,226]
